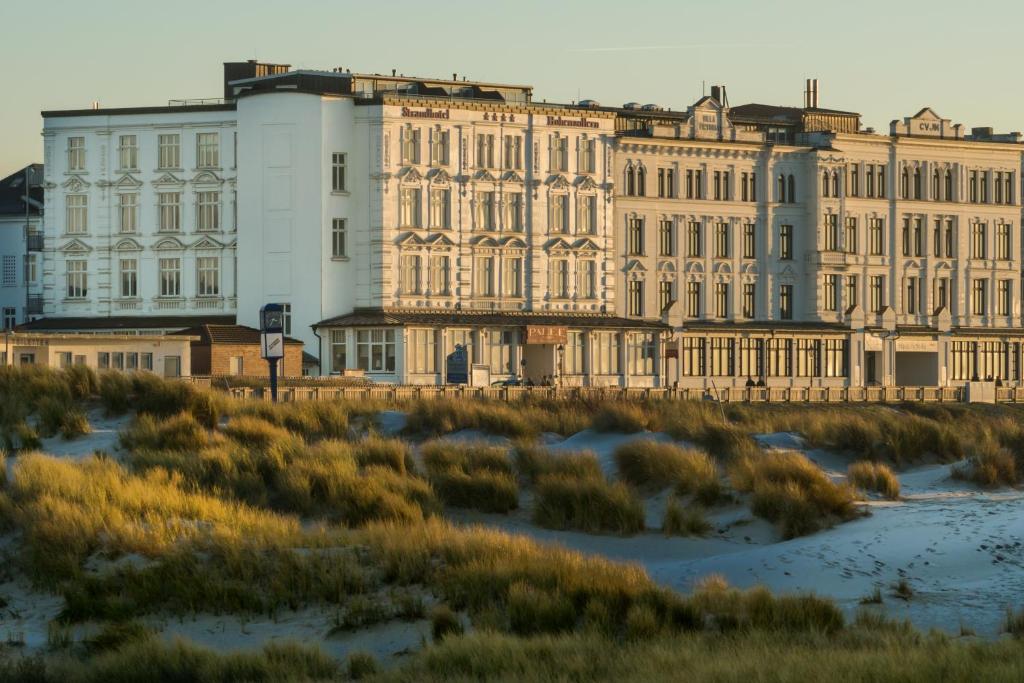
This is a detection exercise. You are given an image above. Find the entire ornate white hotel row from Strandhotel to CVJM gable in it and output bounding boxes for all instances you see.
[19,62,1024,387]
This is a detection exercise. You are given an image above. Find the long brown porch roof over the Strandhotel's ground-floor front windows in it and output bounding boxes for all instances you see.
[313,308,671,330]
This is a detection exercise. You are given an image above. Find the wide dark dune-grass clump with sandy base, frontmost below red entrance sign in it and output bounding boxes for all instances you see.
[534,474,644,533]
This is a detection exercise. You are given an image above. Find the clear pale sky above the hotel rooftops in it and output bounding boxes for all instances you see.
[0,0,1024,175]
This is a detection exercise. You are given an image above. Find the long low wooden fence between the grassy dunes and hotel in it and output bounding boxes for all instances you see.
[184,377,1024,403]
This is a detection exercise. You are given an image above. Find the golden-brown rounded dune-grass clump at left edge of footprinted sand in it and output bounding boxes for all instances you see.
[729,451,856,538]
